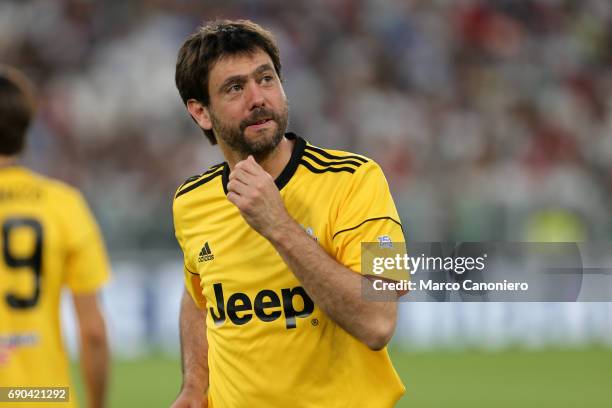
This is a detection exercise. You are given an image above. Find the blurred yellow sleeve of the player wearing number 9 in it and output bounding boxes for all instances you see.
[65,191,110,293]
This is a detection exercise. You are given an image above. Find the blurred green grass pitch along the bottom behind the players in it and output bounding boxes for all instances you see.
[73,348,612,408]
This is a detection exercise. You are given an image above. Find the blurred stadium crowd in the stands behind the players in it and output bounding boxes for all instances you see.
[0,0,612,250]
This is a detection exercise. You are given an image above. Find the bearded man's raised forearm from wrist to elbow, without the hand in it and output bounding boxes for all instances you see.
[269,220,397,350]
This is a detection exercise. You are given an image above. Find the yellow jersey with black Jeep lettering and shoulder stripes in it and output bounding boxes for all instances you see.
[173,133,404,408]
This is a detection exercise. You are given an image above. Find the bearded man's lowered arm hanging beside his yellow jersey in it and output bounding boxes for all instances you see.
[180,291,208,393]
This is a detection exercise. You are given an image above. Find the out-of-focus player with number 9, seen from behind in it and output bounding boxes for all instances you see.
[0,66,109,407]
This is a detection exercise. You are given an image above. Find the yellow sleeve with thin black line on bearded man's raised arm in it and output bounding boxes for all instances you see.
[332,161,404,273]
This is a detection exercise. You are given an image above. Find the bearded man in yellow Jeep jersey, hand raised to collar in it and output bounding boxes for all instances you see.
[174,20,404,408]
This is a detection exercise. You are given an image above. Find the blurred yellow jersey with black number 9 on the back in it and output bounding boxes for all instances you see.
[0,166,109,408]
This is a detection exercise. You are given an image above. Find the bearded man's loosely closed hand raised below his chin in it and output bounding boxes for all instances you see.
[227,156,293,239]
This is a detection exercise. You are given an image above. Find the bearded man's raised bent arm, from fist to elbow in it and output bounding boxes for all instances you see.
[227,156,397,349]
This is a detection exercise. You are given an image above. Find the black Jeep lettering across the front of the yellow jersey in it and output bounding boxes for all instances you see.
[209,283,314,329]
